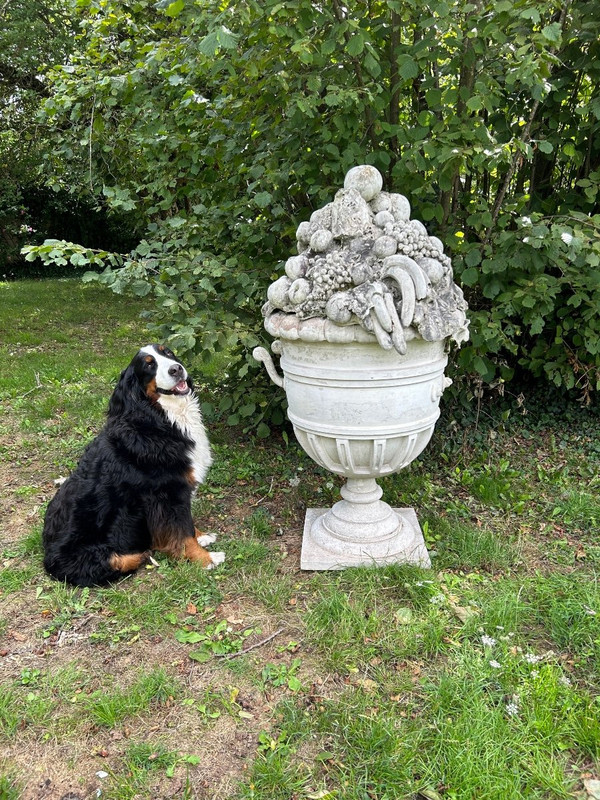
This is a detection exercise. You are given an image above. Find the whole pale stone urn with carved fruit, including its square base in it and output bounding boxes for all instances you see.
[254,165,468,570]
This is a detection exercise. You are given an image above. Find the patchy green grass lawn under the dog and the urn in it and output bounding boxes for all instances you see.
[0,280,600,800]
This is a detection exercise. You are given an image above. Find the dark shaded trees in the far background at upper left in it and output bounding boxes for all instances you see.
[0,0,139,277]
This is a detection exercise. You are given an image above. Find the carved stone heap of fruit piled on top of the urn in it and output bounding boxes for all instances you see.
[264,165,468,352]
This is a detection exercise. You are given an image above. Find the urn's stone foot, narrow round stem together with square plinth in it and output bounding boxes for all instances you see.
[300,478,431,570]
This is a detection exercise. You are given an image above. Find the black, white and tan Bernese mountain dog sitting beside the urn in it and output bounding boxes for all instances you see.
[43,344,225,586]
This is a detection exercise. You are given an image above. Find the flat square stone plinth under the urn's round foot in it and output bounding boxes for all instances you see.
[300,508,431,570]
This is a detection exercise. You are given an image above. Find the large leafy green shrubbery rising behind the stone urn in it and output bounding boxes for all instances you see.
[21,0,600,422]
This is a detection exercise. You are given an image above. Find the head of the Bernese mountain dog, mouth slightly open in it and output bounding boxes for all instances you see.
[108,344,194,415]
